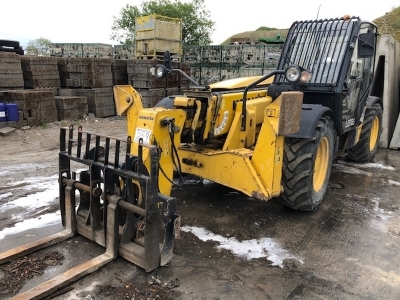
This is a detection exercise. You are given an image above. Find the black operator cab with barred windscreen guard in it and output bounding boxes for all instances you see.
[268,16,378,134]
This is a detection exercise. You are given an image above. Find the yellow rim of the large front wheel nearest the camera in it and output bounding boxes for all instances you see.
[313,137,329,192]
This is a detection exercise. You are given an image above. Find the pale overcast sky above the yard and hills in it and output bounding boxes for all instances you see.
[0,0,400,47]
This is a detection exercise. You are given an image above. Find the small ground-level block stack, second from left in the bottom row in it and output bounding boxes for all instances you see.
[55,96,88,121]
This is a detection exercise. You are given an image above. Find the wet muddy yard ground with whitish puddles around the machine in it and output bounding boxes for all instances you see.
[0,117,400,300]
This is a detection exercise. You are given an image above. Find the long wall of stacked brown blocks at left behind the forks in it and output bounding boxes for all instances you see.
[0,53,189,128]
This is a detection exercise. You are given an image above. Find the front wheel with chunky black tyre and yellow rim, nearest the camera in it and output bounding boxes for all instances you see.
[279,117,335,211]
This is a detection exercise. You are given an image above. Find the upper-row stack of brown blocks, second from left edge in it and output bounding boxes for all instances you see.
[21,56,60,89]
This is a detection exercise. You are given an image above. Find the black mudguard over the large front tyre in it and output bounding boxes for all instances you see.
[286,104,333,139]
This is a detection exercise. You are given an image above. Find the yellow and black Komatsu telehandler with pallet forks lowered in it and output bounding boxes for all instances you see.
[0,16,384,299]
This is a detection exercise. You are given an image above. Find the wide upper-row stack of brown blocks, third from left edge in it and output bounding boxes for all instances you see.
[58,57,113,88]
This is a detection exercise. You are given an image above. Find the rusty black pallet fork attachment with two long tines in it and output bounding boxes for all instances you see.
[0,126,180,300]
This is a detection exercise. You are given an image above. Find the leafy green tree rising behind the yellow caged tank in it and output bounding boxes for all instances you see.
[111,0,215,45]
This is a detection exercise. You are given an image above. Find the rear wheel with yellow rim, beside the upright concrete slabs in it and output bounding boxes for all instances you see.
[347,103,382,162]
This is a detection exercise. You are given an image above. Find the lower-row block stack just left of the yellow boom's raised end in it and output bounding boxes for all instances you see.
[76,87,115,118]
